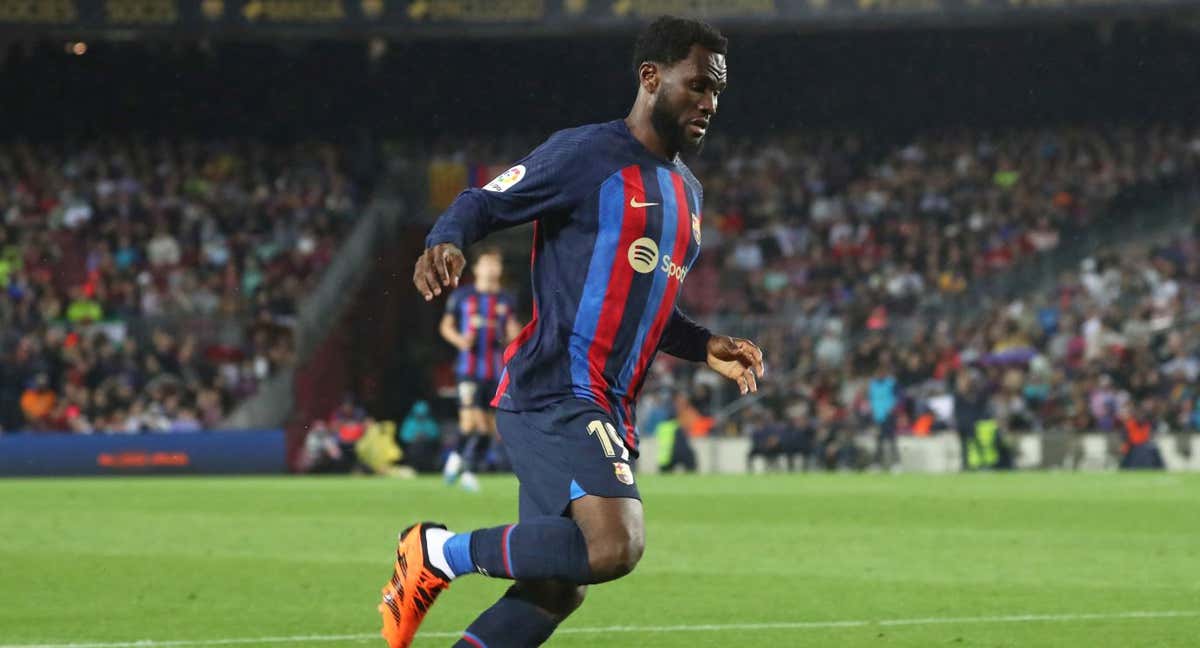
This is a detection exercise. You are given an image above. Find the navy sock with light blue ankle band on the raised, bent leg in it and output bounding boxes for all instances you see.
[451,516,592,584]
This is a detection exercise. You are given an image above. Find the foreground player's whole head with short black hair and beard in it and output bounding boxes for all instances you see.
[634,16,727,152]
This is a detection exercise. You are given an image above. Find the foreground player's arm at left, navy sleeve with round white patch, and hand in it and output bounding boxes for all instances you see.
[413,130,587,301]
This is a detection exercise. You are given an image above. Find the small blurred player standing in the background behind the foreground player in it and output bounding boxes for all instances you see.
[440,247,521,491]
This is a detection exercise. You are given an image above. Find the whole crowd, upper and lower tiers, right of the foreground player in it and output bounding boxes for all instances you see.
[659,127,1200,466]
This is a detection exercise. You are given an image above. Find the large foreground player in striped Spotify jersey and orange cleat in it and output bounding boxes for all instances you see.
[379,17,763,648]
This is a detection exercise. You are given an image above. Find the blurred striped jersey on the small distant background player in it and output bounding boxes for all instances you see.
[446,286,515,382]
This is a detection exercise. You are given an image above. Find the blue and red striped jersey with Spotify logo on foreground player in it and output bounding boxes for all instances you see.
[426,120,708,449]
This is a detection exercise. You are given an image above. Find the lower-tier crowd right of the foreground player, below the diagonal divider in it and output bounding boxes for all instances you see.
[710,221,1200,467]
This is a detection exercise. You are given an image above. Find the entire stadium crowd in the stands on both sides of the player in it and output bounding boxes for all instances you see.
[11,121,1200,463]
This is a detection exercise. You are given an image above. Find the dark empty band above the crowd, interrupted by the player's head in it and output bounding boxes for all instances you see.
[0,22,1200,139]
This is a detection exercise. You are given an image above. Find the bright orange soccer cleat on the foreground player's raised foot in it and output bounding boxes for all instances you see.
[379,522,450,648]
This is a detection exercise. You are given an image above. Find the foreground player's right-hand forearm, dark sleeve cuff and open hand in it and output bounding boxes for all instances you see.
[659,306,764,394]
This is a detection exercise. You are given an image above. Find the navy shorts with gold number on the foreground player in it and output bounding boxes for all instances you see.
[496,400,642,520]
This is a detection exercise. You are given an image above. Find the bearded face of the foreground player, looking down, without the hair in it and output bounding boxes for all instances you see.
[650,46,727,154]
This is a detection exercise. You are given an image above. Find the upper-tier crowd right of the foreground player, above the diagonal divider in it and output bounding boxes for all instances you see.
[683,126,1200,319]
